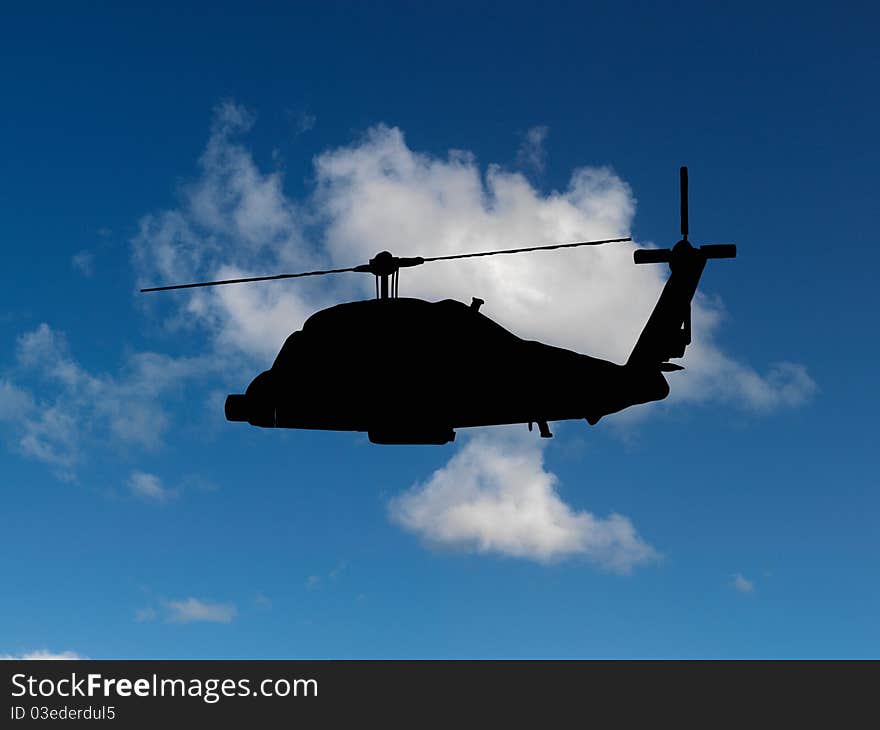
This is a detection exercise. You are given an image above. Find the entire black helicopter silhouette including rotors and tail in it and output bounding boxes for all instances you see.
[141,167,736,445]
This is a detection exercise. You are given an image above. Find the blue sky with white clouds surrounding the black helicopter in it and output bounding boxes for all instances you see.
[0,2,880,658]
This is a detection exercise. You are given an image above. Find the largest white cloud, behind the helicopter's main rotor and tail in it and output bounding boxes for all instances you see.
[133,103,815,408]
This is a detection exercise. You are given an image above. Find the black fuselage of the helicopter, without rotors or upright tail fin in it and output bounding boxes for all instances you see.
[227,298,669,443]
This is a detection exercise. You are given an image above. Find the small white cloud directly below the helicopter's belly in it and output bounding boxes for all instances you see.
[390,431,658,573]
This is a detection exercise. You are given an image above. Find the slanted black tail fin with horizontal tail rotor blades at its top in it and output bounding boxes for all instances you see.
[627,239,736,370]
